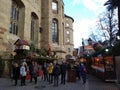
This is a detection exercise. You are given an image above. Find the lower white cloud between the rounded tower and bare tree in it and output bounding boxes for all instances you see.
[73,19,94,48]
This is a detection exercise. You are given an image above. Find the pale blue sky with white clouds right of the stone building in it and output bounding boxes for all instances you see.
[63,0,107,48]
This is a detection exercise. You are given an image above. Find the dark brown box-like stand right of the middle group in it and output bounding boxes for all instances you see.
[67,69,76,82]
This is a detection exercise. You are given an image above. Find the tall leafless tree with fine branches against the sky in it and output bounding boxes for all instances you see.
[97,11,118,45]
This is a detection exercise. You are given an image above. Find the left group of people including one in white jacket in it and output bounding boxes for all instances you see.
[11,61,40,86]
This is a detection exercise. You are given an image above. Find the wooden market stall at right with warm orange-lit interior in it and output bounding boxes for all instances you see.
[91,56,115,82]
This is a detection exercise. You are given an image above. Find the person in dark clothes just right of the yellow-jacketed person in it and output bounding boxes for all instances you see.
[53,63,60,86]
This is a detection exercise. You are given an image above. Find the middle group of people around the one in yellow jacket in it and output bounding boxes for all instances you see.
[42,62,67,86]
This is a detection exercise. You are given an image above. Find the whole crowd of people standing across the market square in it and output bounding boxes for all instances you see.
[12,60,87,86]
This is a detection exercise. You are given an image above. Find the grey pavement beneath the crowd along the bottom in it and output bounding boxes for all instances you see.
[0,75,120,90]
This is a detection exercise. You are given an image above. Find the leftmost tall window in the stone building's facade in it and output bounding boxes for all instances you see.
[9,1,19,35]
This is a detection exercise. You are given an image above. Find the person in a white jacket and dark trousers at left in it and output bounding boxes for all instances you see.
[20,62,27,86]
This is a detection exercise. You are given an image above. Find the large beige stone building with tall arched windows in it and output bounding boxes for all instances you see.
[0,0,74,58]
